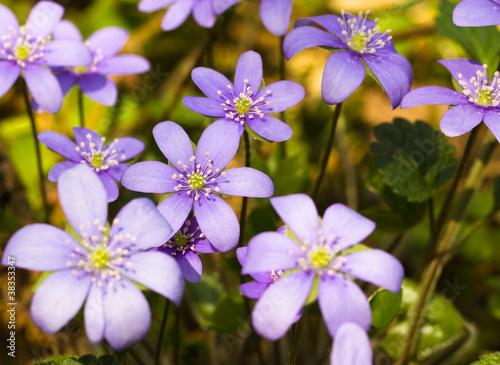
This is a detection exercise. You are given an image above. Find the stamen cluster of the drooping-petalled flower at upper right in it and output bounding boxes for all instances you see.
[338,10,392,54]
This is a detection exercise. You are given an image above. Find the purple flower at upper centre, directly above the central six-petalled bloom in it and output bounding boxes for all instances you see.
[183,51,305,142]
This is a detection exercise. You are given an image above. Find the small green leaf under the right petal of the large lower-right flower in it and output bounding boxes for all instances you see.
[369,288,403,330]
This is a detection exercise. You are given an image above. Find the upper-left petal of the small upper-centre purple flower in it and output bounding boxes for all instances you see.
[191,67,234,99]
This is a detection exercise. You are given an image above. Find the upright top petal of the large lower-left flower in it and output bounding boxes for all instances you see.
[57,164,108,237]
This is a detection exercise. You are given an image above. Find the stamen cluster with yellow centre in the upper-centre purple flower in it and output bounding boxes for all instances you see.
[217,79,271,125]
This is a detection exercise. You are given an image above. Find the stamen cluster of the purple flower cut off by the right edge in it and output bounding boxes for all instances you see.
[458,65,500,108]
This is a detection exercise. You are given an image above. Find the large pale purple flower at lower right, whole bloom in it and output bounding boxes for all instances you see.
[242,194,404,341]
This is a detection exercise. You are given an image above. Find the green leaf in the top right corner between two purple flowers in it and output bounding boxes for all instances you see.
[436,1,500,68]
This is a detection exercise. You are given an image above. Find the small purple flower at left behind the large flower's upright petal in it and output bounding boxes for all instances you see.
[38,127,144,202]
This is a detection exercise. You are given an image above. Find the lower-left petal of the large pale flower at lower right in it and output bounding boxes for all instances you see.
[252,270,315,341]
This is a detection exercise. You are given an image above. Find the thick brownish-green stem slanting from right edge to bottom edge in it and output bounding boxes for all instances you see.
[397,134,498,365]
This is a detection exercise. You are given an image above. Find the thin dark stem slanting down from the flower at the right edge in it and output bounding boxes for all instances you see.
[424,125,481,261]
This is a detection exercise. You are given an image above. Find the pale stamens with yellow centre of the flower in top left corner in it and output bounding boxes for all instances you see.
[0,25,52,67]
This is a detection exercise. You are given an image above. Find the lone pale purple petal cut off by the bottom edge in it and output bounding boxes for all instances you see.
[330,323,373,365]
